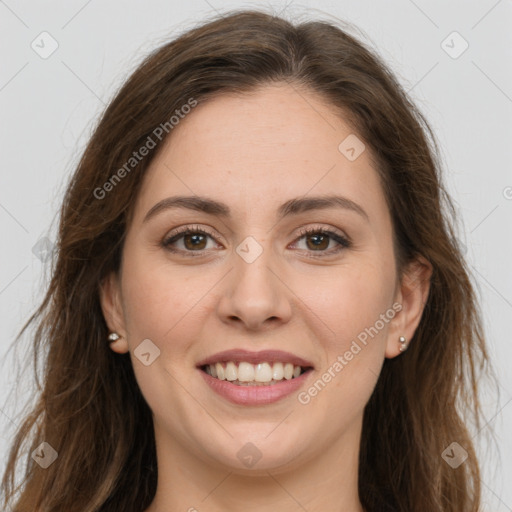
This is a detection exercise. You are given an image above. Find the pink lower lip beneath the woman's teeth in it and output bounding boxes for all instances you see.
[199,370,312,405]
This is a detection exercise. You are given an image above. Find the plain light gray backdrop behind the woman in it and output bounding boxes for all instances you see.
[0,0,512,512]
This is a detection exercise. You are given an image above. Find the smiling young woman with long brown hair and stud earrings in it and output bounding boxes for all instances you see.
[3,11,494,512]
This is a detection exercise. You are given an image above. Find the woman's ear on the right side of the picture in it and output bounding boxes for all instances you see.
[385,256,432,359]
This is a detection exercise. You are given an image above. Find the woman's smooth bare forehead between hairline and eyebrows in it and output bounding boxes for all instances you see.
[131,84,387,226]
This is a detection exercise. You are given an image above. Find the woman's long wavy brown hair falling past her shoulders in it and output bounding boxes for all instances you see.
[2,11,496,512]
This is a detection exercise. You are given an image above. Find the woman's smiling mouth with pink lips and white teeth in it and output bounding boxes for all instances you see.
[197,350,314,405]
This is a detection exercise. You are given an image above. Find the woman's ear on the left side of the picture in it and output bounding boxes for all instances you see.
[100,272,129,354]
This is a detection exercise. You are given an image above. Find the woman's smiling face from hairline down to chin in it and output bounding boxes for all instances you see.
[102,85,424,471]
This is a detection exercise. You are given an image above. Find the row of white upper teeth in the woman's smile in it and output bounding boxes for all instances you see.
[205,361,302,383]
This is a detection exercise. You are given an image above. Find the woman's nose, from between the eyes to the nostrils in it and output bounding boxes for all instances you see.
[218,237,291,329]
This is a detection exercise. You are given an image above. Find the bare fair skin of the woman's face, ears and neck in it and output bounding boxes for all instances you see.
[101,84,431,512]
